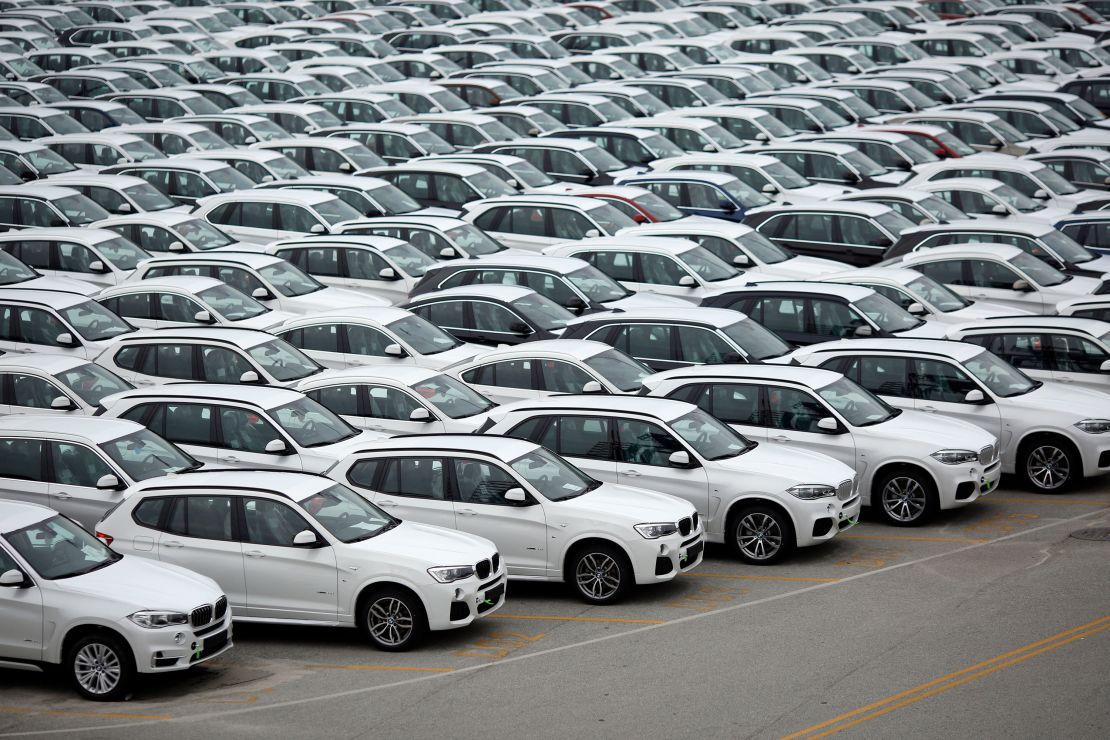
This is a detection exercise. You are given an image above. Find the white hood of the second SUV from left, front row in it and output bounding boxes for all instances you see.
[355,521,497,561]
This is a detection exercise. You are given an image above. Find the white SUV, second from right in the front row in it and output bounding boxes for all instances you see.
[644,365,1001,526]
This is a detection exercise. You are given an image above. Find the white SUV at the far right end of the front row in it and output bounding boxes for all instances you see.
[794,339,1110,493]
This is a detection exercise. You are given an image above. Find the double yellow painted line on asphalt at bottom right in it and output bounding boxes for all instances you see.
[783,617,1110,740]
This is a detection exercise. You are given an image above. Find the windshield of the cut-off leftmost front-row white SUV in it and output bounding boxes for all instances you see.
[3,516,123,580]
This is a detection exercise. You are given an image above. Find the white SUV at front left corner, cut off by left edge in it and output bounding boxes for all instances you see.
[0,500,231,701]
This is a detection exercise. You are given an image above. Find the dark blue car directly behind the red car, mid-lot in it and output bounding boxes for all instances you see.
[617,170,771,221]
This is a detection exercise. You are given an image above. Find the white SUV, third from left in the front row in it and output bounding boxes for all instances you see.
[327,435,705,604]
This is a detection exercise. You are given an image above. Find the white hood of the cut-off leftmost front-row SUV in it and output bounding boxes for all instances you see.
[53,555,223,618]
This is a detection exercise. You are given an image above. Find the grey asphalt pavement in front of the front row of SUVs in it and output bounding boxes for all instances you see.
[0,480,1110,740]
